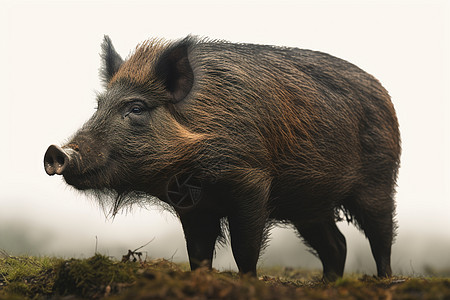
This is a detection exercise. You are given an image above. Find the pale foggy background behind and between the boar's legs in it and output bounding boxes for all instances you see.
[0,0,450,274]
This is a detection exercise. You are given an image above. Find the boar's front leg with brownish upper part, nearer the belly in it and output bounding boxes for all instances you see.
[228,172,270,276]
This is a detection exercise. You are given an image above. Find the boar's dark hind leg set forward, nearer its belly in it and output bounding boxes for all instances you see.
[293,220,347,281]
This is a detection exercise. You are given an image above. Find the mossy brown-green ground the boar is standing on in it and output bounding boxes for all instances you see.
[0,254,450,300]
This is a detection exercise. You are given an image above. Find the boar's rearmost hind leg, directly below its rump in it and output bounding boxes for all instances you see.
[344,189,395,277]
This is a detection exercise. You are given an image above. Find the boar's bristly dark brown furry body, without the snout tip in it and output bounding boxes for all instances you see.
[47,37,401,280]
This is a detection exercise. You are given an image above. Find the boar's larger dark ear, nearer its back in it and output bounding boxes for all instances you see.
[156,38,194,103]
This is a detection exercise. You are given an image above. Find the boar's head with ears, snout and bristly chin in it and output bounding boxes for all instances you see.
[44,36,205,213]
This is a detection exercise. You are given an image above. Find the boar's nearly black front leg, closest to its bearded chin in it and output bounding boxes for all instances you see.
[180,211,221,270]
